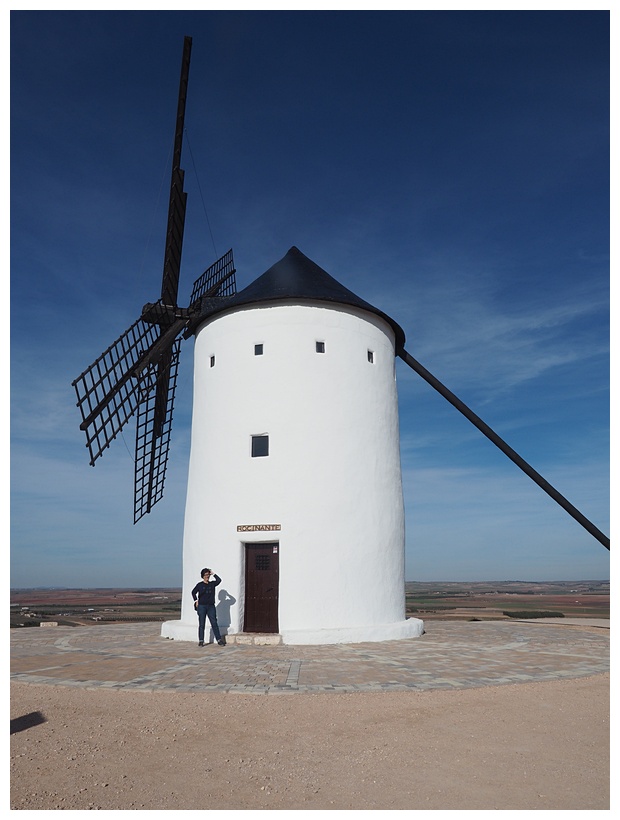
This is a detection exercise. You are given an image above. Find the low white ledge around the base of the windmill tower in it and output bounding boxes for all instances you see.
[161,618,424,646]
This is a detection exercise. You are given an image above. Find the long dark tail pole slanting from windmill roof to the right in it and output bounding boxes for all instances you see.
[398,348,610,549]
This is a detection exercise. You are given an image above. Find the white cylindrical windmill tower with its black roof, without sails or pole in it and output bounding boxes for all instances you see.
[162,248,423,644]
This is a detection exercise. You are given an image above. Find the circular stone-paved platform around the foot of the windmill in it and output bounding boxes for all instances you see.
[11,621,609,694]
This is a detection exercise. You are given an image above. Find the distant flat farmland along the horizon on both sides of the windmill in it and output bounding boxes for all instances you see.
[11,581,609,628]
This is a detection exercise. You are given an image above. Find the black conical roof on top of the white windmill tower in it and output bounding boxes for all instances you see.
[196,247,405,348]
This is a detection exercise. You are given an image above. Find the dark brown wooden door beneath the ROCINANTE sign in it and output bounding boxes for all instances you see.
[243,543,279,633]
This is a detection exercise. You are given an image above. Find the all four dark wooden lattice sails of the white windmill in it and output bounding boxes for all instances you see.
[73,37,236,523]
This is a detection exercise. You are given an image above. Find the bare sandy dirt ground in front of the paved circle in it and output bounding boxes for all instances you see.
[11,675,609,810]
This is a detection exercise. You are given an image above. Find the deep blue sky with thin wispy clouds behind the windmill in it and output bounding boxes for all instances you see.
[11,11,610,587]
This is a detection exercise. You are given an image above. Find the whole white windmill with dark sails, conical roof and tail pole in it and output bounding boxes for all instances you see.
[73,38,609,643]
